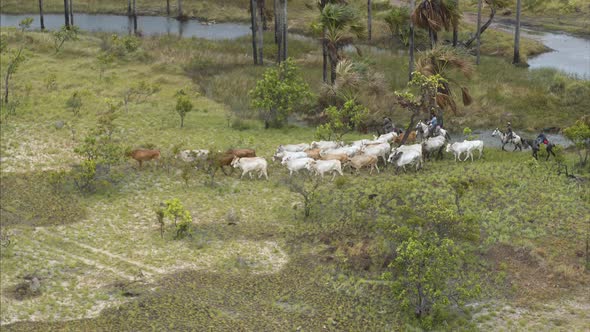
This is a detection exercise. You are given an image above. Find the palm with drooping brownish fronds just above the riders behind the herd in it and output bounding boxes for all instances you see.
[416,46,474,125]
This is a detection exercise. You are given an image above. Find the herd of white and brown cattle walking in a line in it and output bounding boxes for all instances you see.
[131,132,490,179]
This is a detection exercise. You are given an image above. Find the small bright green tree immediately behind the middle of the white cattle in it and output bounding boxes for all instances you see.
[316,99,369,140]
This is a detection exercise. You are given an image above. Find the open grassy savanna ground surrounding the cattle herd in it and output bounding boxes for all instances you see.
[0,25,590,331]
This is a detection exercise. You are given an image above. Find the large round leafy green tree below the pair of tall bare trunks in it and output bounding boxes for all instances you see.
[249,58,311,129]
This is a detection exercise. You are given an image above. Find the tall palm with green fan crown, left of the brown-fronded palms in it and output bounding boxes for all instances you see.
[320,3,365,84]
